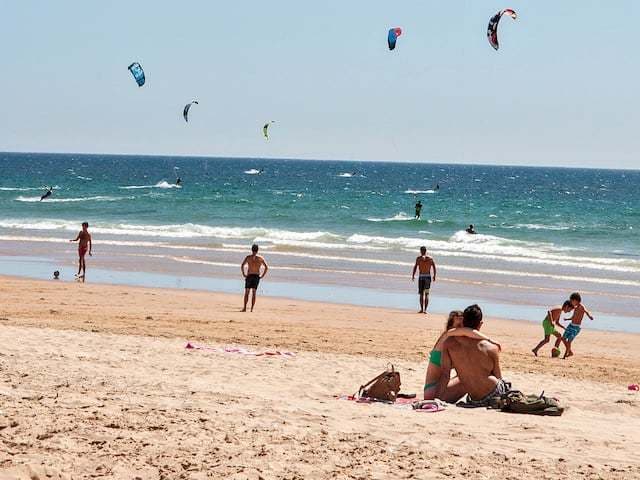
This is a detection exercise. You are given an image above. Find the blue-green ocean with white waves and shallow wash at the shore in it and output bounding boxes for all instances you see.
[0,153,640,325]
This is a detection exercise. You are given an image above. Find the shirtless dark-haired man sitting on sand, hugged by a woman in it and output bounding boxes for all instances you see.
[436,305,508,406]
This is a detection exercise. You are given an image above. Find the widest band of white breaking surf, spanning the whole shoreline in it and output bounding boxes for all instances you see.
[0,219,640,277]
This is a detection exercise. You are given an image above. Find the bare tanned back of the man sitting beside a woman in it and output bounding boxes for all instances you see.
[439,337,502,401]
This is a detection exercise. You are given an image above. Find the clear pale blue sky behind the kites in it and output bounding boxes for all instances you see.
[0,0,640,168]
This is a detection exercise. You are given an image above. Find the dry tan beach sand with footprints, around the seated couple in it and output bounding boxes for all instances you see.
[0,277,640,479]
